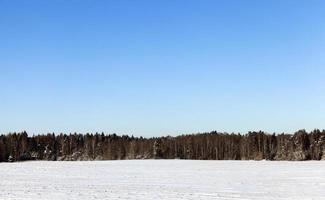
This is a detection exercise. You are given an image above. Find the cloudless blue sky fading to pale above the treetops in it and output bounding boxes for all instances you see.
[0,0,325,136]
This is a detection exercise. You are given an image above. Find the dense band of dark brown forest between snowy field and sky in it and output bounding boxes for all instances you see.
[0,129,325,162]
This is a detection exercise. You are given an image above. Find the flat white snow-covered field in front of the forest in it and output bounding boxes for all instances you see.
[0,160,325,200]
